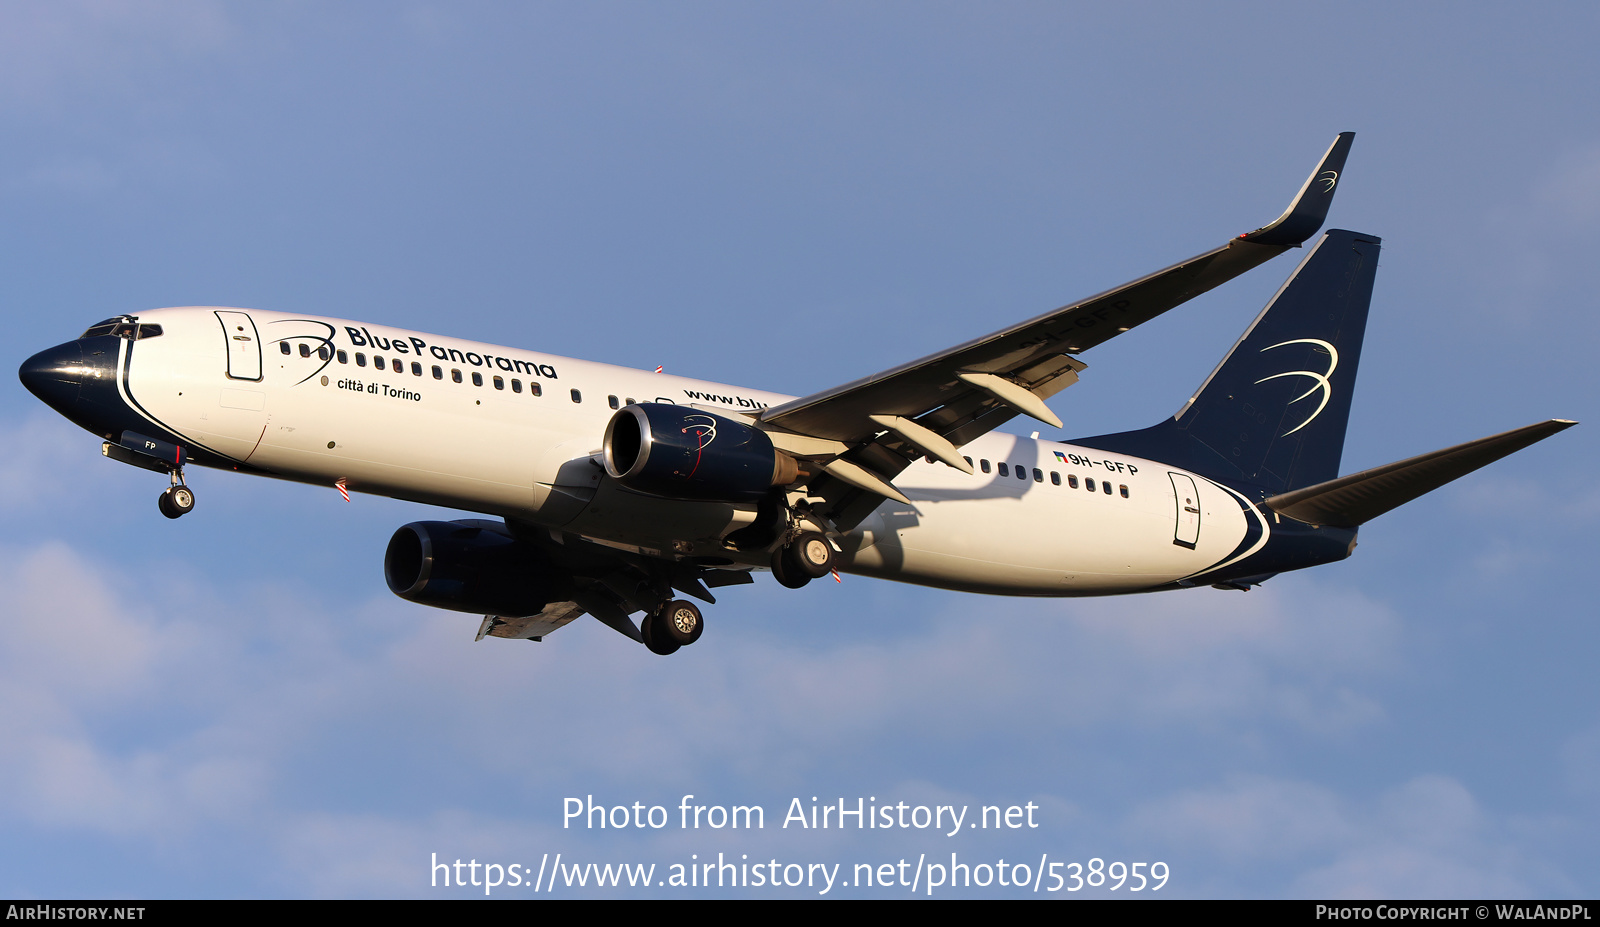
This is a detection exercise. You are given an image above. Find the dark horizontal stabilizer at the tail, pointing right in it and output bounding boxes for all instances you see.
[1261,418,1578,528]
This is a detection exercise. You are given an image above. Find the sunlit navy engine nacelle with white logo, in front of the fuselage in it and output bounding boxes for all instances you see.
[605,402,800,503]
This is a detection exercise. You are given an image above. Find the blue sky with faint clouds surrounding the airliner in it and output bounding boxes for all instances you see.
[0,2,1600,897]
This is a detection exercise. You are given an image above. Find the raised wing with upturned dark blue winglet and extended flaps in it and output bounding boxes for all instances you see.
[760,133,1355,520]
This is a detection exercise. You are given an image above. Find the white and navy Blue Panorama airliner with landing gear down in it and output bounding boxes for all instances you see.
[21,133,1574,655]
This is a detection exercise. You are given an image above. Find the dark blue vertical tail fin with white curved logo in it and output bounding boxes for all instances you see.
[1072,229,1379,493]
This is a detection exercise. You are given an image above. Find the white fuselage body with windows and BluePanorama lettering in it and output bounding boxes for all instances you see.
[120,307,1266,596]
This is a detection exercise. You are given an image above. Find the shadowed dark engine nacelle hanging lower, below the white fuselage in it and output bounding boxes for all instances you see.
[384,522,560,616]
